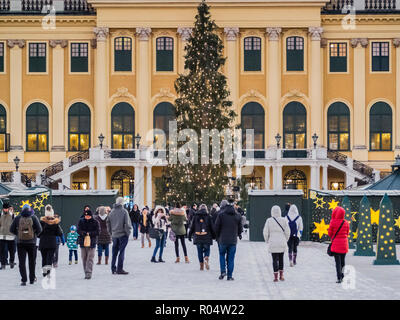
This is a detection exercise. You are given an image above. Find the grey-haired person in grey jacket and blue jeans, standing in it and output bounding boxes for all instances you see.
[107,197,132,274]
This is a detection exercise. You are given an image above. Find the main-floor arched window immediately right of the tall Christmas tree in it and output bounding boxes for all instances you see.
[241,102,265,149]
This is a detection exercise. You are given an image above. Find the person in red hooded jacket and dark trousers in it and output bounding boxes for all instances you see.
[328,207,350,283]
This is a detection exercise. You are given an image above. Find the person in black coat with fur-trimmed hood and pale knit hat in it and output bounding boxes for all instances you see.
[39,204,63,277]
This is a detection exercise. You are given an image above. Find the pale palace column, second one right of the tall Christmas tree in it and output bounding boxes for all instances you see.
[266,28,282,148]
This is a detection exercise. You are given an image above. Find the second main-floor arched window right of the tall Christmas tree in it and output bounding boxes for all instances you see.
[283,101,307,149]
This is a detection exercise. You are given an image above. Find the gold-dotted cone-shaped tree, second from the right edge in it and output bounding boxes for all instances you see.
[354,196,375,256]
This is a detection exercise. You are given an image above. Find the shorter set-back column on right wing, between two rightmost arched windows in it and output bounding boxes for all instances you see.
[350,39,368,161]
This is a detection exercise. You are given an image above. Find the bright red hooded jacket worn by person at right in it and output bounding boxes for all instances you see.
[328,207,350,253]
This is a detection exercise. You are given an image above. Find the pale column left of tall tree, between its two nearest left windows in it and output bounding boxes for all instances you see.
[136,28,152,144]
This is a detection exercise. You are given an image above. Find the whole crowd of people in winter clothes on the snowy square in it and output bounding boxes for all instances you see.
[0,197,349,286]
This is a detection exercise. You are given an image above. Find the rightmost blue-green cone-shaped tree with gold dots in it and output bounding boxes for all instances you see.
[374,193,400,265]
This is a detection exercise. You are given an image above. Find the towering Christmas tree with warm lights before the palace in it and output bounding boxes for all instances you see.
[156,1,236,203]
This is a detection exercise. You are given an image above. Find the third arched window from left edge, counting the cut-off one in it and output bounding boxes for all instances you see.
[68,102,90,151]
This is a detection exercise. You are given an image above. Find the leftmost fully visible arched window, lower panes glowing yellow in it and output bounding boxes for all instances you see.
[26,102,49,151]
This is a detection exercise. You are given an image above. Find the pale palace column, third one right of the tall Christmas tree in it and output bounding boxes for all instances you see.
[307,27,324,146]
